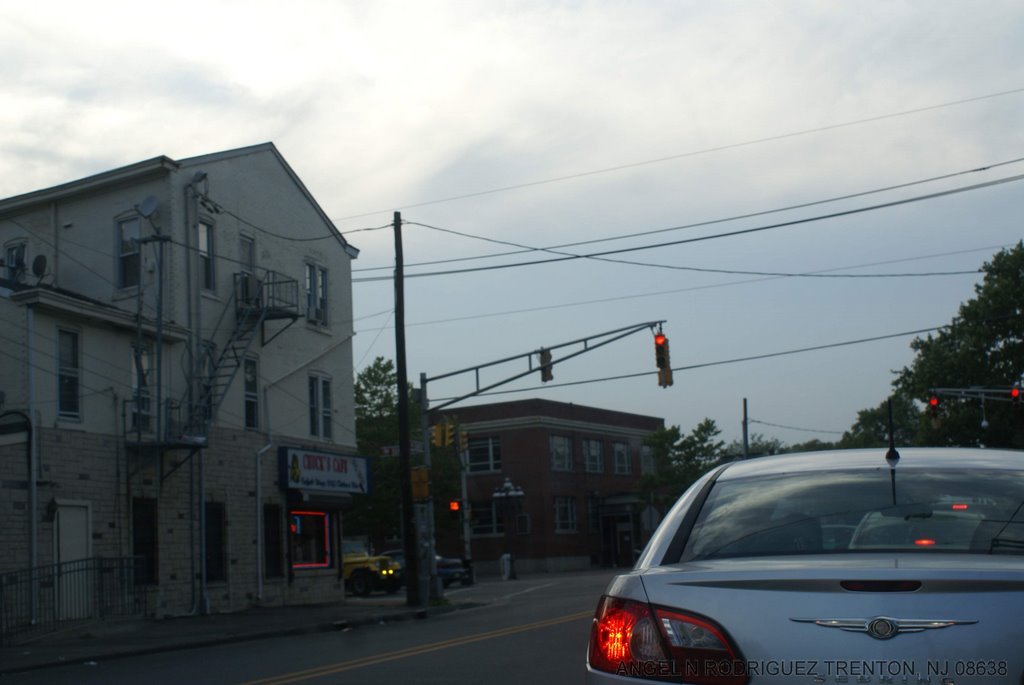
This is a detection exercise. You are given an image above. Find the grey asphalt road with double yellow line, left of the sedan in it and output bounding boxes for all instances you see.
[2,571,612,685]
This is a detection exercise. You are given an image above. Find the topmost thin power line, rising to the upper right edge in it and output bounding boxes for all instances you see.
[333,83,1024,221]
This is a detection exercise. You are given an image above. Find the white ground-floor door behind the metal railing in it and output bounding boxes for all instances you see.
[53,503,94,620]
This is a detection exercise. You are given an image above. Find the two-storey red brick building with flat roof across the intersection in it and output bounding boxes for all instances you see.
[437,399,665,573]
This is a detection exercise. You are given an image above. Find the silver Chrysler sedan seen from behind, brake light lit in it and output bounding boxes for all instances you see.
[587,448,1024,685]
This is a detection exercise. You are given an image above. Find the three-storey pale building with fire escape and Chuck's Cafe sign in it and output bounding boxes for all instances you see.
[0,143,369,618]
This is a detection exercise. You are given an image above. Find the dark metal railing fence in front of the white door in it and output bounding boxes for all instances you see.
[0,557,146,646]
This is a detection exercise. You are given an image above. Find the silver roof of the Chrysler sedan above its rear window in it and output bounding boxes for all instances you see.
[718,447,1024,480]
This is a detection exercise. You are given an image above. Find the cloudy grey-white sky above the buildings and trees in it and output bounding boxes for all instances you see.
[0,0,1024,443]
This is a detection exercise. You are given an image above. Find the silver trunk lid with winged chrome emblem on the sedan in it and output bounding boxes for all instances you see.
[642,554,1024,684]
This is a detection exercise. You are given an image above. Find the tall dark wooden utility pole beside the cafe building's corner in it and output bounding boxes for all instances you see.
[394,212,424,606]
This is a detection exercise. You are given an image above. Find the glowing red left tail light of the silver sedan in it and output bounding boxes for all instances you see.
[589,597,748,685]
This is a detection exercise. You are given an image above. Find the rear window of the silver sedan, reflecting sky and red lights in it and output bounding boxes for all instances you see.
[681,468,1024,561]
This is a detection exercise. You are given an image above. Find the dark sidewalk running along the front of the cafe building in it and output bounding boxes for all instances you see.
[0,593,471,675]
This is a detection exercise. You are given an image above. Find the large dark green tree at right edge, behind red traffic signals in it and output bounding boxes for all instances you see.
[894,243,1024,448]
